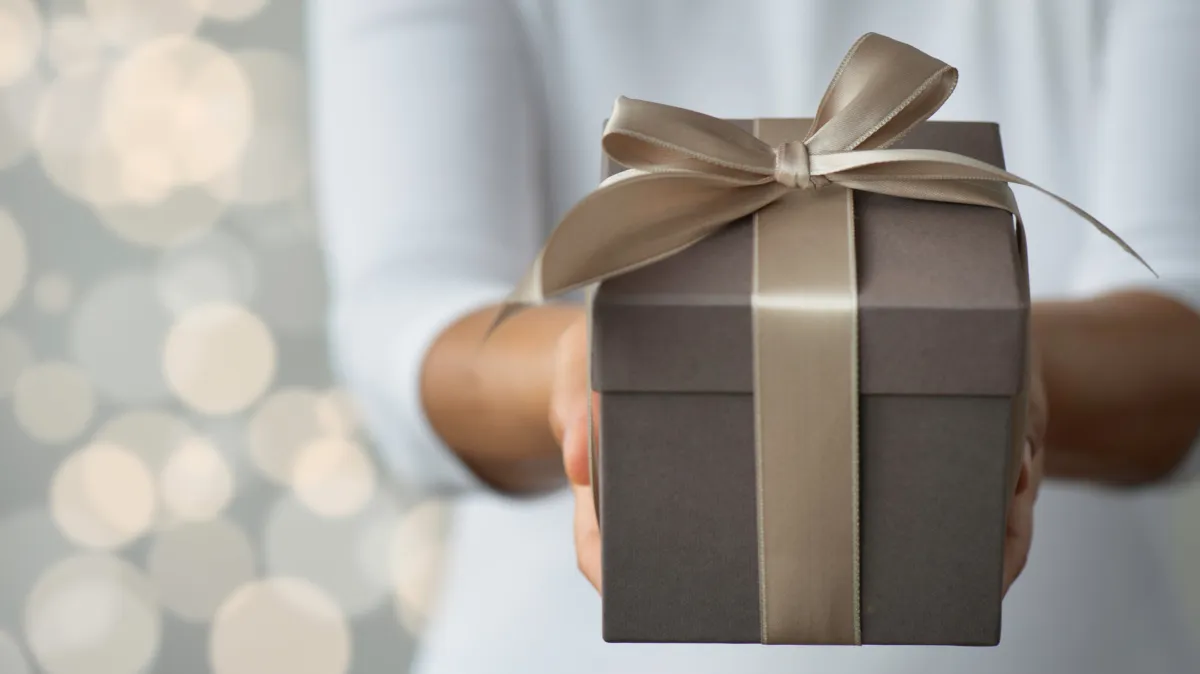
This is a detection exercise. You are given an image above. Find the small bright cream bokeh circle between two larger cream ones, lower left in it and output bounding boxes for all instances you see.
[158,438,234,522]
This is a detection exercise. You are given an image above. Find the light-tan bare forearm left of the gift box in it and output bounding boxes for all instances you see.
[421,306,582,493]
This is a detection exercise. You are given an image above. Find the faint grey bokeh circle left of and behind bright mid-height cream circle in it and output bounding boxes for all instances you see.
[71,272,170,404]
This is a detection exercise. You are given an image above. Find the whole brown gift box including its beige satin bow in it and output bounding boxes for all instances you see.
[497,30,1145,645]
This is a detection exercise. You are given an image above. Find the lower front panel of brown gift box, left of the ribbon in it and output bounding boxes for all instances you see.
[600,393,760,643]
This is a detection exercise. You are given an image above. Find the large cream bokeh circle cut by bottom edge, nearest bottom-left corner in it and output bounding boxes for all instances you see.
[24,554,162,674]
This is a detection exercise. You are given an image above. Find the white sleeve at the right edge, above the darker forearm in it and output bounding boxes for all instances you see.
[1075,0,1200,479]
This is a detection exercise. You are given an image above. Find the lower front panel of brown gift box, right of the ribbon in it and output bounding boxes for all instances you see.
[860,396,1013,645]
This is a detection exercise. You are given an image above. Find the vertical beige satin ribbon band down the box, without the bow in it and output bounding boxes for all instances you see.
[751,120,862,644]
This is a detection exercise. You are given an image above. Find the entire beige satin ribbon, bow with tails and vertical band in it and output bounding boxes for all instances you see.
[497,34,1150,644]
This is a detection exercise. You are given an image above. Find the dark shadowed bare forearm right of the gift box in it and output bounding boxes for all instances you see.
[1032,293,1200,485]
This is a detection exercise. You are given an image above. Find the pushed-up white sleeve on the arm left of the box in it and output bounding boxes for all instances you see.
[308,0,544,491]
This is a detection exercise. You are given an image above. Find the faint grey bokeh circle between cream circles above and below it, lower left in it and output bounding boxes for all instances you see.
[264,486,398,615]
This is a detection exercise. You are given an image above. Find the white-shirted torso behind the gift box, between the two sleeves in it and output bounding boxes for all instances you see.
[418,0,1200,674]
